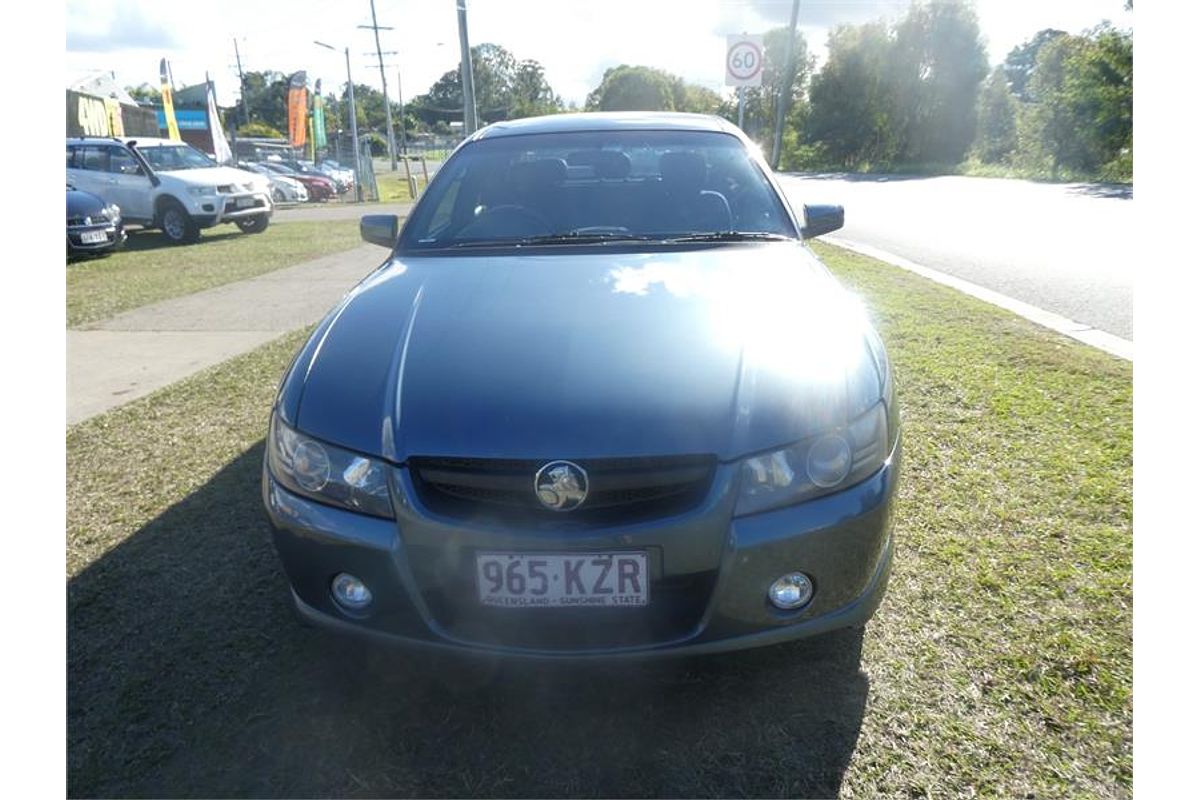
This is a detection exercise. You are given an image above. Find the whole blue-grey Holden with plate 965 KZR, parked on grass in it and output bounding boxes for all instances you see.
[263,113,900,658]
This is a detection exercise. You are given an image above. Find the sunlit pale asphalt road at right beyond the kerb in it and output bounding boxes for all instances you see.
[780,175,1134,341]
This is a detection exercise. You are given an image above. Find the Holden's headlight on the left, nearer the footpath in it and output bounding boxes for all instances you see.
[266,415,395,518]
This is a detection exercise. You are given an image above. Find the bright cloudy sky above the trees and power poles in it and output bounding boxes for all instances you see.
[65,0,1133,106]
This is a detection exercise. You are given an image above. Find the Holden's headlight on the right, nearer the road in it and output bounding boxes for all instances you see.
[734,403,888,516]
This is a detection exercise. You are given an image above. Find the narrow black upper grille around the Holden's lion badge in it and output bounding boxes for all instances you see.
[408,456,716,523]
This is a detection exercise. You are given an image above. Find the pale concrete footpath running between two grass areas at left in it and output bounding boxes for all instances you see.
[67,244,388,425]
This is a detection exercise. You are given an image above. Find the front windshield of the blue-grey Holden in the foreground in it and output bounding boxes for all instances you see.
[401,131,796,249]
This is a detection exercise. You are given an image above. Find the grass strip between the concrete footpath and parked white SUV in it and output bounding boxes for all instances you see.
[67,219,361,326]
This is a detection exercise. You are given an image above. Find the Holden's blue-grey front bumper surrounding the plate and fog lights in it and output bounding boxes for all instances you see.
[263,444,900,658]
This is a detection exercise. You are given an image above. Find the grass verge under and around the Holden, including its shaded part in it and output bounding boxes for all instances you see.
[67,241,1132,798]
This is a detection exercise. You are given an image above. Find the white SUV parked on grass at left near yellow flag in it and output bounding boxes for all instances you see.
[67,137,272,243]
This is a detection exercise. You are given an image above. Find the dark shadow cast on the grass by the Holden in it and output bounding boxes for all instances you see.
[67,444,868,796]
